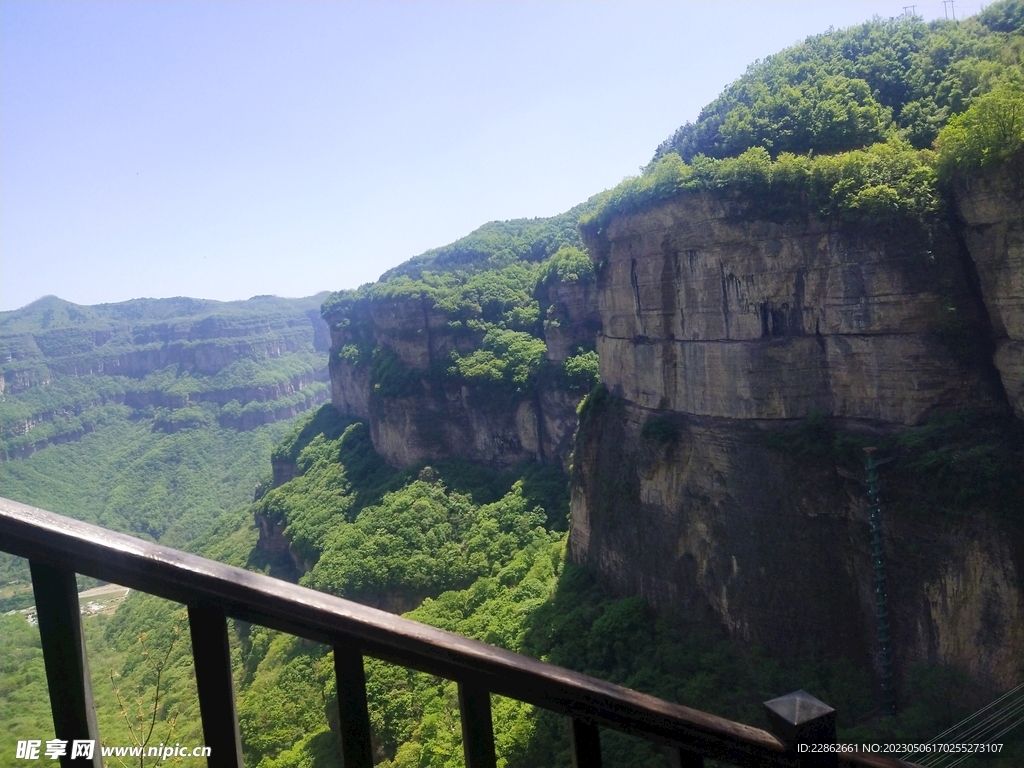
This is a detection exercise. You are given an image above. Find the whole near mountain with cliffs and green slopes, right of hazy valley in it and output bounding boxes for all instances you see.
[3,6,1024,768]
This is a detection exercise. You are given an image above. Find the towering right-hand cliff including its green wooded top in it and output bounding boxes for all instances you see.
[570,10,1024,692]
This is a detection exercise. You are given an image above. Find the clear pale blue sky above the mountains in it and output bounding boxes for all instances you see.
[0,0,981,309]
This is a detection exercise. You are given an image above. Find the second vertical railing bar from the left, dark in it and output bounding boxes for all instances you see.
[188,603,243,768]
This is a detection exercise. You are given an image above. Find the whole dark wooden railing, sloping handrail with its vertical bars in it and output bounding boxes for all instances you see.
[0,499,908,768]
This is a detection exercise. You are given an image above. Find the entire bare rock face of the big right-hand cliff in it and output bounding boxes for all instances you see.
[570,184,1024,687]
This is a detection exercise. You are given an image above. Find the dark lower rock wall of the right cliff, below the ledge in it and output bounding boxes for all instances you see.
[570,397,1024,689]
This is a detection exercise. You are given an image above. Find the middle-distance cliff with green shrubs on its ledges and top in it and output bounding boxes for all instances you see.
[324,203,599,468]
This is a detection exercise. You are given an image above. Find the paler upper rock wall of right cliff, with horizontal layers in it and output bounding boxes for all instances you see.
[589,196,992,424]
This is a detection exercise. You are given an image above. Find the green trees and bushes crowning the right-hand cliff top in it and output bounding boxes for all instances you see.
[581,0,1024,233]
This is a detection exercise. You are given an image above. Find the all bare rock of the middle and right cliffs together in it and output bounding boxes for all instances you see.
[315,174,1024,700]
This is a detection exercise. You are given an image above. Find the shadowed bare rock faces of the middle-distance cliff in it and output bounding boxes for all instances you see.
[327,283,600,468]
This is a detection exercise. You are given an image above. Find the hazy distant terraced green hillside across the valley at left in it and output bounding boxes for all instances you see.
[0,296,328,610]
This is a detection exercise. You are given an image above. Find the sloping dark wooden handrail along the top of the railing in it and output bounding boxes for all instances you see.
[0,498,908,768]
